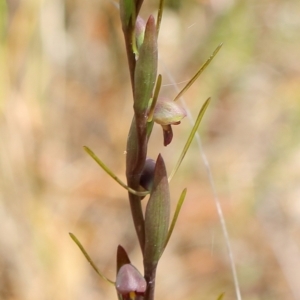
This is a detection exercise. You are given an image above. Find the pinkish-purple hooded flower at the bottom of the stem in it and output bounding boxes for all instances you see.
[116,264,147,298]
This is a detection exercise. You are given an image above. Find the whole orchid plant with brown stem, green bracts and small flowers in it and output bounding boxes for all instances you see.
[70,0,221,300]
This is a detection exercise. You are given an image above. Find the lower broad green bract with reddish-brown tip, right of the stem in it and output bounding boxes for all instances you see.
[144,154,170,269]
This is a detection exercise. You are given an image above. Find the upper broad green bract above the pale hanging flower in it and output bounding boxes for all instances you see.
[134,16,157,116]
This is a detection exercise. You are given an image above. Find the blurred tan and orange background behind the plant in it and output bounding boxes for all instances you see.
[0,0,300,300]
